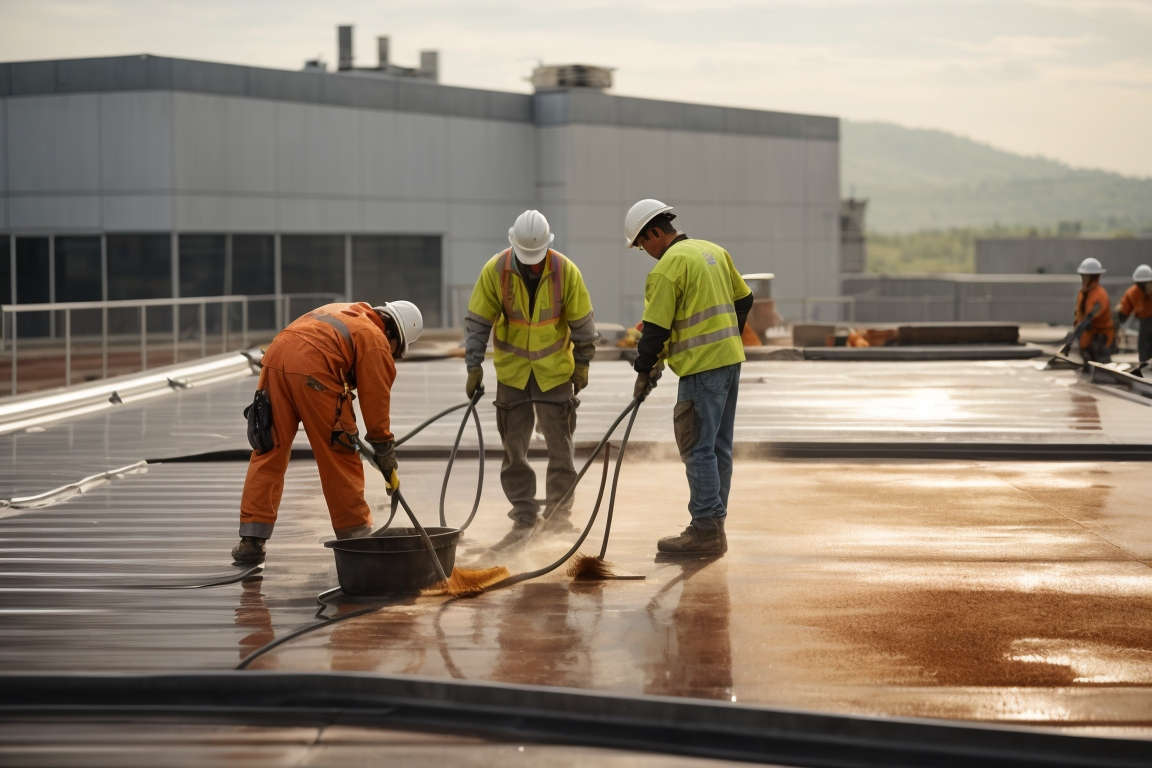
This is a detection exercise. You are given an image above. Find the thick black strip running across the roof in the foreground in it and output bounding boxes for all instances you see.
[0,672,1149,767]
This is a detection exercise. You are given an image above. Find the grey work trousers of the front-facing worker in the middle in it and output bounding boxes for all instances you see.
[495,375,579,524]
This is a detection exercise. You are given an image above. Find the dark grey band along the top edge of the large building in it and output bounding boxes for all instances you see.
[0,54,840,142]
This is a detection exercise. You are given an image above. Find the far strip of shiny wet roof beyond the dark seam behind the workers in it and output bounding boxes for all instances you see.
[0,360,1152,499]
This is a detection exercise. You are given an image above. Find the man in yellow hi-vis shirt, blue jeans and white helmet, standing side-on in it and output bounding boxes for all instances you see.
[624,198,752,555]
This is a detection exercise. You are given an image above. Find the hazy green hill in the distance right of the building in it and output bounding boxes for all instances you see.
[840,120,1152,233]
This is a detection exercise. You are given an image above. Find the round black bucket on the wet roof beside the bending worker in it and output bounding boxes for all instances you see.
[324,526,460,595]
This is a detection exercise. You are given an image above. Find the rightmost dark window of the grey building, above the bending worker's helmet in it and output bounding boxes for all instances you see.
[351,235,442,328]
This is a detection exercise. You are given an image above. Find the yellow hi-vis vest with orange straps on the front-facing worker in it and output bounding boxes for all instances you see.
[468,249,592,391]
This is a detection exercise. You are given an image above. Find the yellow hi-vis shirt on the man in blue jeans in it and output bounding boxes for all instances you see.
[644,238,752,377]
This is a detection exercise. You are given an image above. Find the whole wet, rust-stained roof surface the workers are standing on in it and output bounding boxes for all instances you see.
[0,360,1152,735]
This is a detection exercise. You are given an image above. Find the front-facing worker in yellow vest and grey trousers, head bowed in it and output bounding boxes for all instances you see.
[464,211,596,543]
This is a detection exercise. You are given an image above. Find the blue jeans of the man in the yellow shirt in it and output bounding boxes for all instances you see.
[673,363,740,520]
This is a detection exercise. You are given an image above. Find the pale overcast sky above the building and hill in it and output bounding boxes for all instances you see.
[0,0,1152,176]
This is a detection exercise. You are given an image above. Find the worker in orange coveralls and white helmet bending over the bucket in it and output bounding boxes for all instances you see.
[232,302,424,563]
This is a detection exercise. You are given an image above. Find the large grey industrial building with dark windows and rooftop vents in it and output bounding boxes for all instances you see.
[0,36,840,335]
